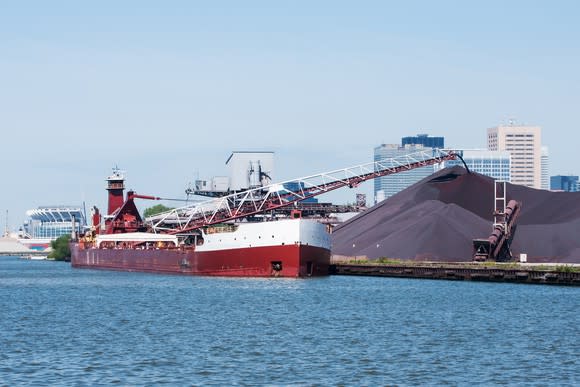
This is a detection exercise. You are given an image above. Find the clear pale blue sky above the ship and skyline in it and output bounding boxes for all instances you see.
[0,0,580,229]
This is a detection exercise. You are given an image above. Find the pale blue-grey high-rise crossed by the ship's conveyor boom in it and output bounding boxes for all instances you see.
[374,144,434,203]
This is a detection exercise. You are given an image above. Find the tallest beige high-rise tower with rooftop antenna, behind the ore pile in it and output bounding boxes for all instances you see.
[487,124,542,188]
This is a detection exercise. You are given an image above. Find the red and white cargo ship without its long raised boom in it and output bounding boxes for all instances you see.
[71,171,330,277]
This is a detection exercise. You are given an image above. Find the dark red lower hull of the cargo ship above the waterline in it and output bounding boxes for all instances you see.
[71,243,330,277]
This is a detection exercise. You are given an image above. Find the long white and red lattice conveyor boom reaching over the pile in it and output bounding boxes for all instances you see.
[146,149,459,234]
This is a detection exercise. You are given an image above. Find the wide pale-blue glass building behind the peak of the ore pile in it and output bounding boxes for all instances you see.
[439,149,511,182]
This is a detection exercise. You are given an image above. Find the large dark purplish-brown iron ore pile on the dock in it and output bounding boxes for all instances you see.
[332,166,580,263]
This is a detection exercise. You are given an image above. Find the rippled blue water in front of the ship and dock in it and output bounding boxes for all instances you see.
[0,257,580,386]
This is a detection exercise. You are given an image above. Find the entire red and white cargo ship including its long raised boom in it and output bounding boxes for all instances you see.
[71,149,460,277]
